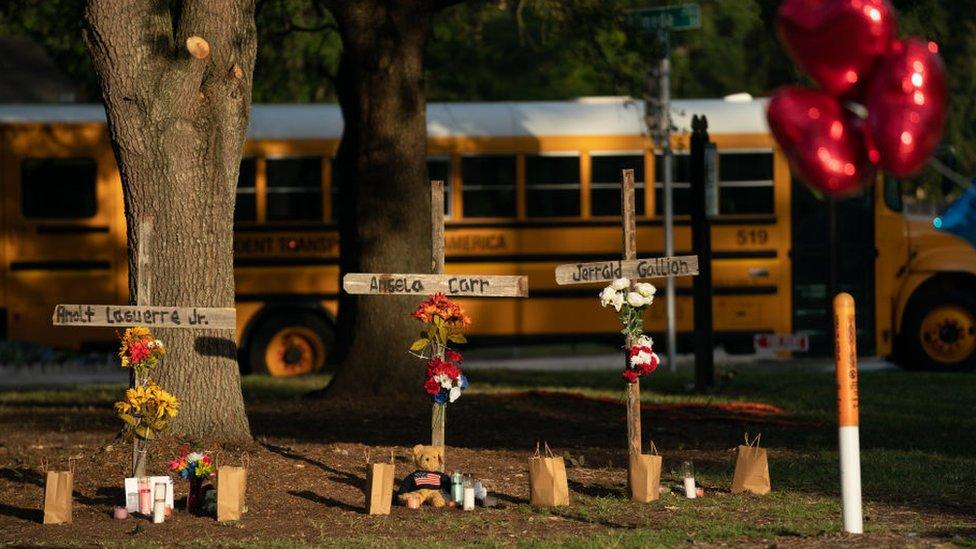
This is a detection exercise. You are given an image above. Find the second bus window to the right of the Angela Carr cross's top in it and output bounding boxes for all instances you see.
[525,155,580,217]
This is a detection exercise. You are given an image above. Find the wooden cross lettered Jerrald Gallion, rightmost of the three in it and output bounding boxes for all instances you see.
[556,170,698,461]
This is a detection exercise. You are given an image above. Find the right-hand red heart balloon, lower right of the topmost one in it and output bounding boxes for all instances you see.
[867,38,948,177]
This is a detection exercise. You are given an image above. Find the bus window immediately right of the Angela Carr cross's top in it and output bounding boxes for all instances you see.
[461,155,515,217]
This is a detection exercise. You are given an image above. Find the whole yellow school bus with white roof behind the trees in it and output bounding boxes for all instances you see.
[0,98,976,376]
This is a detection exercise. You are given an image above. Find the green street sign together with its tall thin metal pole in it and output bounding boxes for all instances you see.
[627,4,701,372]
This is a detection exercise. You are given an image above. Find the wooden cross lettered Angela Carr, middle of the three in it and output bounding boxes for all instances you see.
[342,181,529,458]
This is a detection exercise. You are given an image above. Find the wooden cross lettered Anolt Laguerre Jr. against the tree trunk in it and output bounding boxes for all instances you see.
[51,216,237,477]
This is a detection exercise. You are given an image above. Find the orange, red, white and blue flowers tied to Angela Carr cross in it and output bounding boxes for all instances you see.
[410,293,471,404]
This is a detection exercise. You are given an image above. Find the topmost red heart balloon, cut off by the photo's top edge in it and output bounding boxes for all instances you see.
[777,0,897,100]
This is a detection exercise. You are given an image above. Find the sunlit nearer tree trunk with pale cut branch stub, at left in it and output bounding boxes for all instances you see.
[85,0,255,443]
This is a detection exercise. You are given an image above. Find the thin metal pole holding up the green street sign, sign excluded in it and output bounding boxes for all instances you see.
[658,30,678,373]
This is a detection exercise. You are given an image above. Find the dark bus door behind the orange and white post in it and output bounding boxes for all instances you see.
[791,179,877,356]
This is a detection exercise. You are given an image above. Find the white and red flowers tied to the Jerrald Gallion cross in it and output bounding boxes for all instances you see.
[600,278,660,383]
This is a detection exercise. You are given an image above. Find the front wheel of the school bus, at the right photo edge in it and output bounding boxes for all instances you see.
[902,290,976,371]
